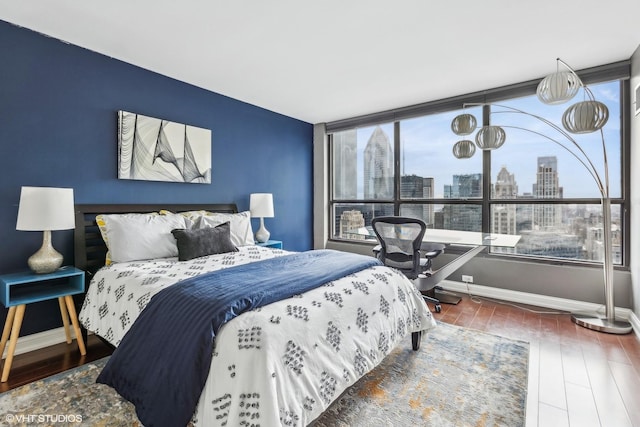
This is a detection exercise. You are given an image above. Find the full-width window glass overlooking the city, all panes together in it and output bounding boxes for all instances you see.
[330,69,628,265]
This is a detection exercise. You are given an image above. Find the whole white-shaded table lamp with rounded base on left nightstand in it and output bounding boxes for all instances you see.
[16,187,75,274]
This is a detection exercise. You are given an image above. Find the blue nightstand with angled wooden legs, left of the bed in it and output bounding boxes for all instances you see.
[0,267,87,382]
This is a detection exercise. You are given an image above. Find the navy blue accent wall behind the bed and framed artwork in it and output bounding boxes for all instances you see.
[0,21,313,335]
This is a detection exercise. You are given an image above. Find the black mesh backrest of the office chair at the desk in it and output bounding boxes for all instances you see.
[371,216,427,279]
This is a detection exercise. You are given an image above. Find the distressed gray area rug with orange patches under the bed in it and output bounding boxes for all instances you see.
[0,323,529,427]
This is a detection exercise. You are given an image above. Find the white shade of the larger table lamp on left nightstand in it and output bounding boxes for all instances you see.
[16,187,75,231]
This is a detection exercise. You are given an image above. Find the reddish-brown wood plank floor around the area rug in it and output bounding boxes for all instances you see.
[0,296,640,427]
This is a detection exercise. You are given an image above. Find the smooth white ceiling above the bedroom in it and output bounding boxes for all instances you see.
[0,0,640,123]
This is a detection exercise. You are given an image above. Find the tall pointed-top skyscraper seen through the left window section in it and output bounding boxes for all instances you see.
[364,126,393,200]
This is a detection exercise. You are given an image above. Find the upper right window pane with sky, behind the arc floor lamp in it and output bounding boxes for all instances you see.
[491,81,622,199]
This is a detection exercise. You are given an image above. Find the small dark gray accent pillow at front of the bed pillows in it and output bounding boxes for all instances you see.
[171,221,238,261]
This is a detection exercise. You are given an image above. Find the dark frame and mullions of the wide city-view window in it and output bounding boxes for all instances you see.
[326,61,631,270]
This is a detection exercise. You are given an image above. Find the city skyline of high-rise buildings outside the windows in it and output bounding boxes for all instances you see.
[333,118,621,260]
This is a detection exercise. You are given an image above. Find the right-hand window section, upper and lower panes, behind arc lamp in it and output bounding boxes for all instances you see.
[491,81,623,264]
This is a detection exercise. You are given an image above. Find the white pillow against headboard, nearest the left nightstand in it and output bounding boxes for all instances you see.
[101,214,187,262]
